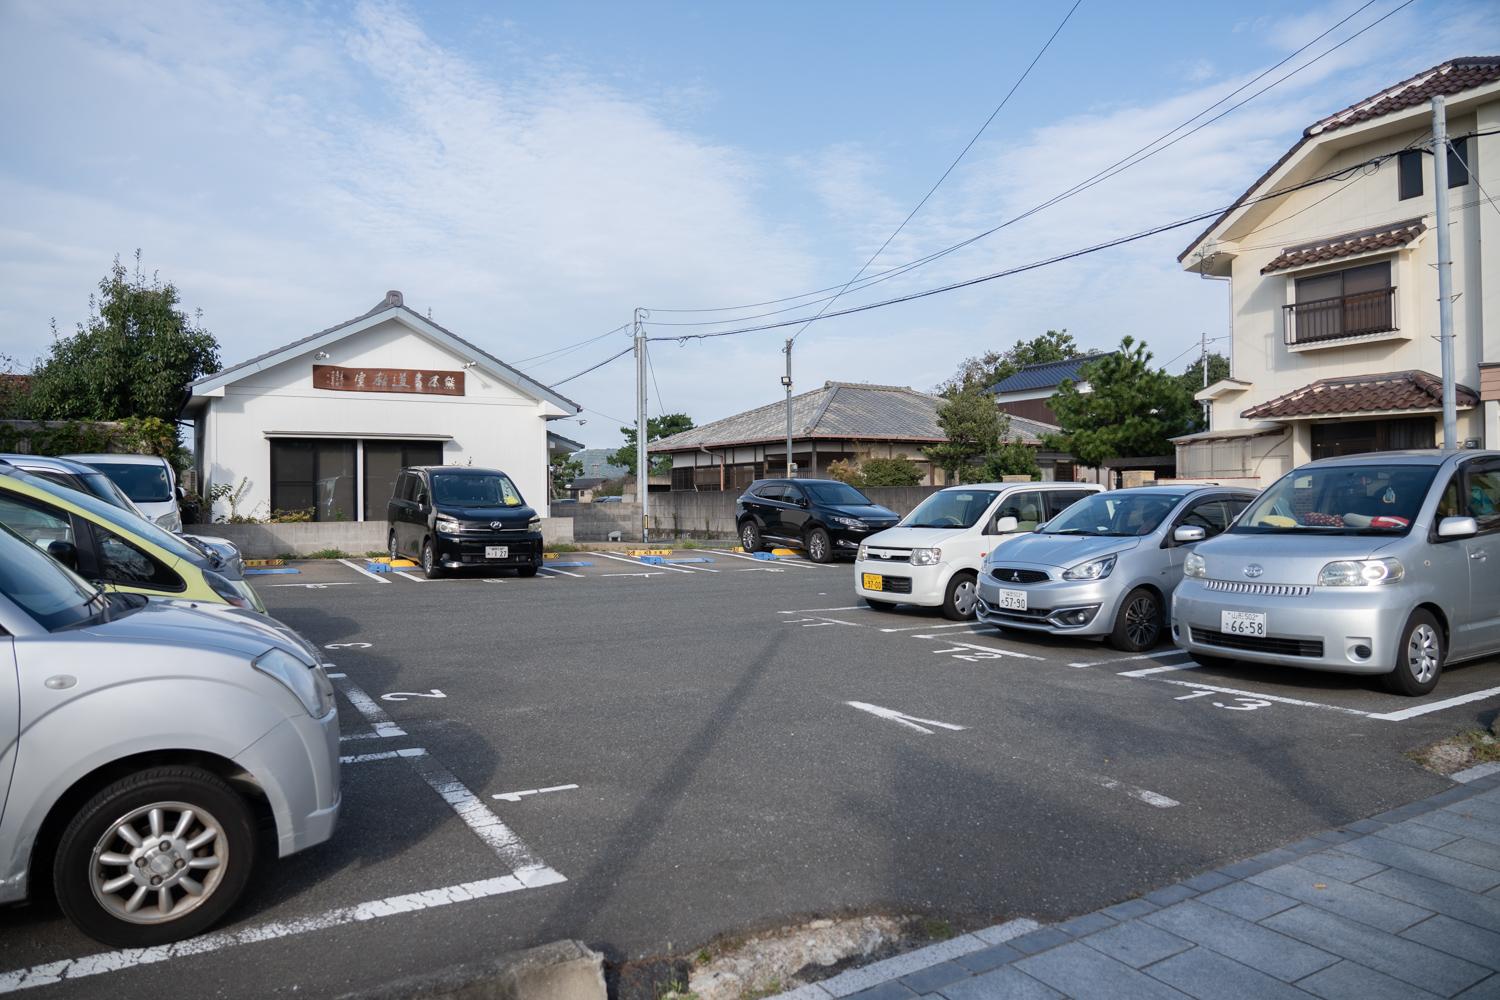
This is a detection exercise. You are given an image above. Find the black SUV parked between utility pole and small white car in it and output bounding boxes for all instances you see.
[735,480,900,562]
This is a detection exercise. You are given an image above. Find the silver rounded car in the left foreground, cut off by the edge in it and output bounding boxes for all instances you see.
[0,526,341,948]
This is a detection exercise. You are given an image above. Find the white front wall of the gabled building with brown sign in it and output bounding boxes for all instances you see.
[203,319,548,516]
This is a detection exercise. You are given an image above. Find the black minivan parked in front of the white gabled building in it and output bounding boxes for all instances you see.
[386,465,542,579]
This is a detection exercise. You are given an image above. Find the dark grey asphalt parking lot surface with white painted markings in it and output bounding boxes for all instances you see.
[0,552,1500,997]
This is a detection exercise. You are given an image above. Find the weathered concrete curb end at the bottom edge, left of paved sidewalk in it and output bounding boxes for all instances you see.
[339,940,608,1000]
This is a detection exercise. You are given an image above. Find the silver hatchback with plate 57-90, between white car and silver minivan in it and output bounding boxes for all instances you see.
[977,486,1254,651]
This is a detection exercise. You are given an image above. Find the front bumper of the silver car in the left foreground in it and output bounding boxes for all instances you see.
[234,709,342,858]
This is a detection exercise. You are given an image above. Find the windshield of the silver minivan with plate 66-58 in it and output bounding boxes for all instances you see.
[1232,465,1437,535]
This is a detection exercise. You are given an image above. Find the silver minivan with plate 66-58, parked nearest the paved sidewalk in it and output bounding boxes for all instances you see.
[1172,451,1500,696]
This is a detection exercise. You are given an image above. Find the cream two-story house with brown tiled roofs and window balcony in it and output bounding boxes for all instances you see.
[1178,57,1500,483]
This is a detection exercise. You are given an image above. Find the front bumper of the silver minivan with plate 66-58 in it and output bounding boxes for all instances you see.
[1172,579,1412,673]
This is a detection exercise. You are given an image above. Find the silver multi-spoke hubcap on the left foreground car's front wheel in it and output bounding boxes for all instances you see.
[89,802,230,924]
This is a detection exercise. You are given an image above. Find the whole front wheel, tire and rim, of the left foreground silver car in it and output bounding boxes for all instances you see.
[53,766,257,948]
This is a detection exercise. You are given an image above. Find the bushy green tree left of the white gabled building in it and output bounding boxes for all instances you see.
[27,250,219,421]
